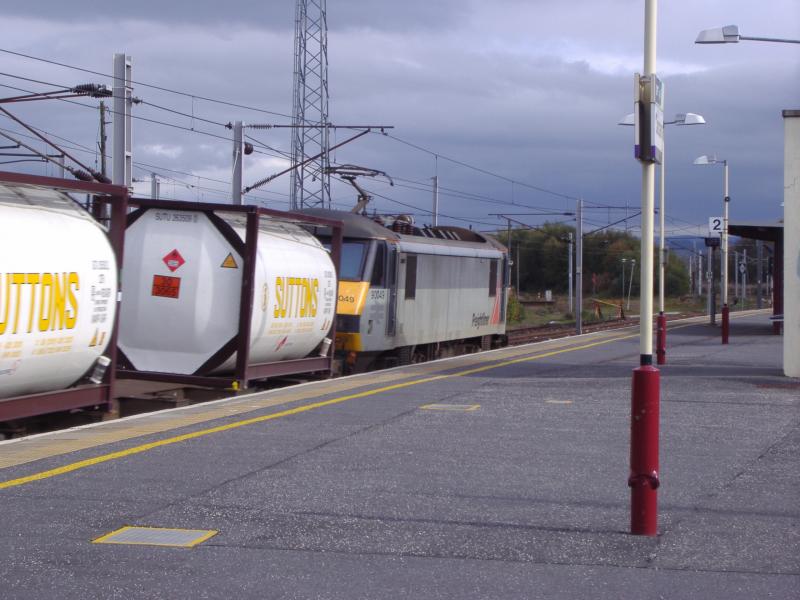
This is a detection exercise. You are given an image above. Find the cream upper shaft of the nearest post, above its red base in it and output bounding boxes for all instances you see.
[639,0,658,366]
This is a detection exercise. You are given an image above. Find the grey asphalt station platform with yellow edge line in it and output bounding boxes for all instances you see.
[0,313,800,600]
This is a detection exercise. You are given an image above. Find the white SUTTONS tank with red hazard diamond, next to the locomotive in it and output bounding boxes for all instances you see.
[119,208,336,375]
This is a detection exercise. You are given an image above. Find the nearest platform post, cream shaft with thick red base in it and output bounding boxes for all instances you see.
[628,0,661,536]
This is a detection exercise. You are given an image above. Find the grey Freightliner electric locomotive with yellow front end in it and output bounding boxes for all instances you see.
[306,209,508,370]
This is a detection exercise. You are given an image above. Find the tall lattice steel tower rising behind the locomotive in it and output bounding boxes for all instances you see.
[291,0,331,210]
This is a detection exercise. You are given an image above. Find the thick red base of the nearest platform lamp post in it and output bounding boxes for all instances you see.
[628,365,661,535]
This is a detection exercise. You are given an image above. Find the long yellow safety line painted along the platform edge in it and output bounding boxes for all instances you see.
[0,316,752,490]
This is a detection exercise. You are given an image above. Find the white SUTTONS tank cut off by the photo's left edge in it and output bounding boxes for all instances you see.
[0,190,117,399]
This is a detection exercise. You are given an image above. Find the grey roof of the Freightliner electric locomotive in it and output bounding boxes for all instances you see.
[301,208,506,252]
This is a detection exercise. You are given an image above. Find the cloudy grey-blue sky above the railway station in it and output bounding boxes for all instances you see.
[0,0,800,236]
